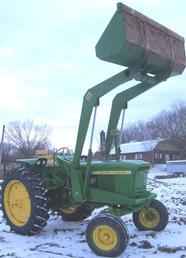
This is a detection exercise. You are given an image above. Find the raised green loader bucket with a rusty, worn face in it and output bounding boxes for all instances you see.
[96,3,186,76]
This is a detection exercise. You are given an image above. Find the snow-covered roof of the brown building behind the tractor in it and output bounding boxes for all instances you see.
[111,139,163,154]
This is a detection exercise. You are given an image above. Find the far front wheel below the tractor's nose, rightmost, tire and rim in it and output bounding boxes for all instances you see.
[133,200,169,231]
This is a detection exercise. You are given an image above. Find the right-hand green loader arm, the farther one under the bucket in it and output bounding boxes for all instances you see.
[105,75,166,157]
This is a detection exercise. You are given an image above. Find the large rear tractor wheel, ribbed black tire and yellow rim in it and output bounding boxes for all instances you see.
[2,170,49,235]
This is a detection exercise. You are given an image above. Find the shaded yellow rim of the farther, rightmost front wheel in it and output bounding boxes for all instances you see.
[139,208,160,229]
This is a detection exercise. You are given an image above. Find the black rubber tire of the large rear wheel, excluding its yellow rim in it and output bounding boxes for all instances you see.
[2,169,49,235]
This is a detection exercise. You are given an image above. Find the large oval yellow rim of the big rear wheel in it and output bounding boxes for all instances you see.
[4,180,31,227]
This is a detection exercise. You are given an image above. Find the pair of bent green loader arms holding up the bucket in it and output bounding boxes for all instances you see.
[73,69,166,168]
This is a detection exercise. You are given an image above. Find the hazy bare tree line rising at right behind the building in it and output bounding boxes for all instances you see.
[122,102,186,158]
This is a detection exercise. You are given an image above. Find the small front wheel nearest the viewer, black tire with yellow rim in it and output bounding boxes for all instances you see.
[86,214,129,257]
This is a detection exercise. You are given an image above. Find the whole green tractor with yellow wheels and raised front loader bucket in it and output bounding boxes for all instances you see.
[2,3,185,257]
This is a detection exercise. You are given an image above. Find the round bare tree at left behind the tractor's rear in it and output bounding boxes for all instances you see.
[6,121,50,157]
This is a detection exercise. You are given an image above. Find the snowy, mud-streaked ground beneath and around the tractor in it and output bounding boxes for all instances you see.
[0,168,186,258]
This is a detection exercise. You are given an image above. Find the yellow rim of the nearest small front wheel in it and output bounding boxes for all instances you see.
[93,225,118,251]
